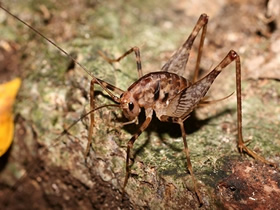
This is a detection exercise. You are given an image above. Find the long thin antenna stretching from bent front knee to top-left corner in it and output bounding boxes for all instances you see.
[0,2,94,78]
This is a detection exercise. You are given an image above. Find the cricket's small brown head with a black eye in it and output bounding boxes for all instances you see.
[120,91,141,121]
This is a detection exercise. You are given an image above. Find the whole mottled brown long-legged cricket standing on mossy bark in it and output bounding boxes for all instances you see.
[0,6,272,204]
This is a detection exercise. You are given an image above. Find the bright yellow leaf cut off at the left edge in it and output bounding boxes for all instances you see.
[0,78,21,157]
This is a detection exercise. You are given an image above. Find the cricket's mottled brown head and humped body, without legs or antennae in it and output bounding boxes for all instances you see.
[121,72,191,120]
